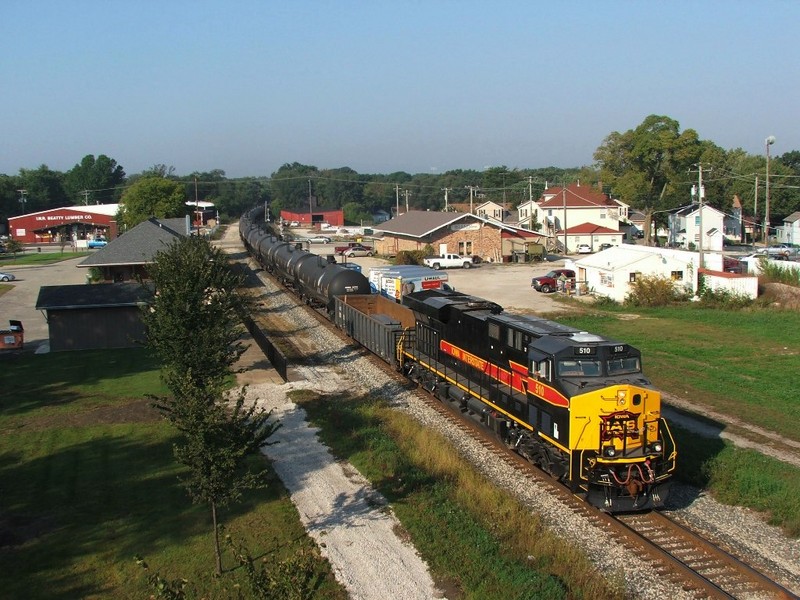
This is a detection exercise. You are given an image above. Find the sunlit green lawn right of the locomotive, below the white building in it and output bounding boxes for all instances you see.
[558,305,800,440]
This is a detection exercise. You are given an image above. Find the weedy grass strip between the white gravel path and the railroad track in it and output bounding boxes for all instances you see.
[292,392,623,600]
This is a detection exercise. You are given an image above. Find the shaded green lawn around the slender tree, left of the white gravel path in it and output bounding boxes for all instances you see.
[0,350,343,599]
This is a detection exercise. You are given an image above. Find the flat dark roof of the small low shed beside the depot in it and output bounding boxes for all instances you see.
[36,283,153,310]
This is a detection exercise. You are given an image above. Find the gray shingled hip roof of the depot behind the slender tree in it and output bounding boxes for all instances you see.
[78,217,186,267]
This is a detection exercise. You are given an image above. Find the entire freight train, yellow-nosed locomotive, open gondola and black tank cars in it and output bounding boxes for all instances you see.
[239,209,677,512]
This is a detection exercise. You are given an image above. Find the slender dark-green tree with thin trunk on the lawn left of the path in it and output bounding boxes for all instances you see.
[143,236,277,574]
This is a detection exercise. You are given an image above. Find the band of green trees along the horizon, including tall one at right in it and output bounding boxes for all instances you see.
[0,115,800,234]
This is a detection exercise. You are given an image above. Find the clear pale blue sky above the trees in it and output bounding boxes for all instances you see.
[0,0,800,177]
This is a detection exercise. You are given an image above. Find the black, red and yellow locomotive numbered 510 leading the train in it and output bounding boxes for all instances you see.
[398,290,676,512]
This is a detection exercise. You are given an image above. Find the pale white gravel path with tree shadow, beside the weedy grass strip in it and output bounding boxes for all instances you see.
[248,378,442,600]
